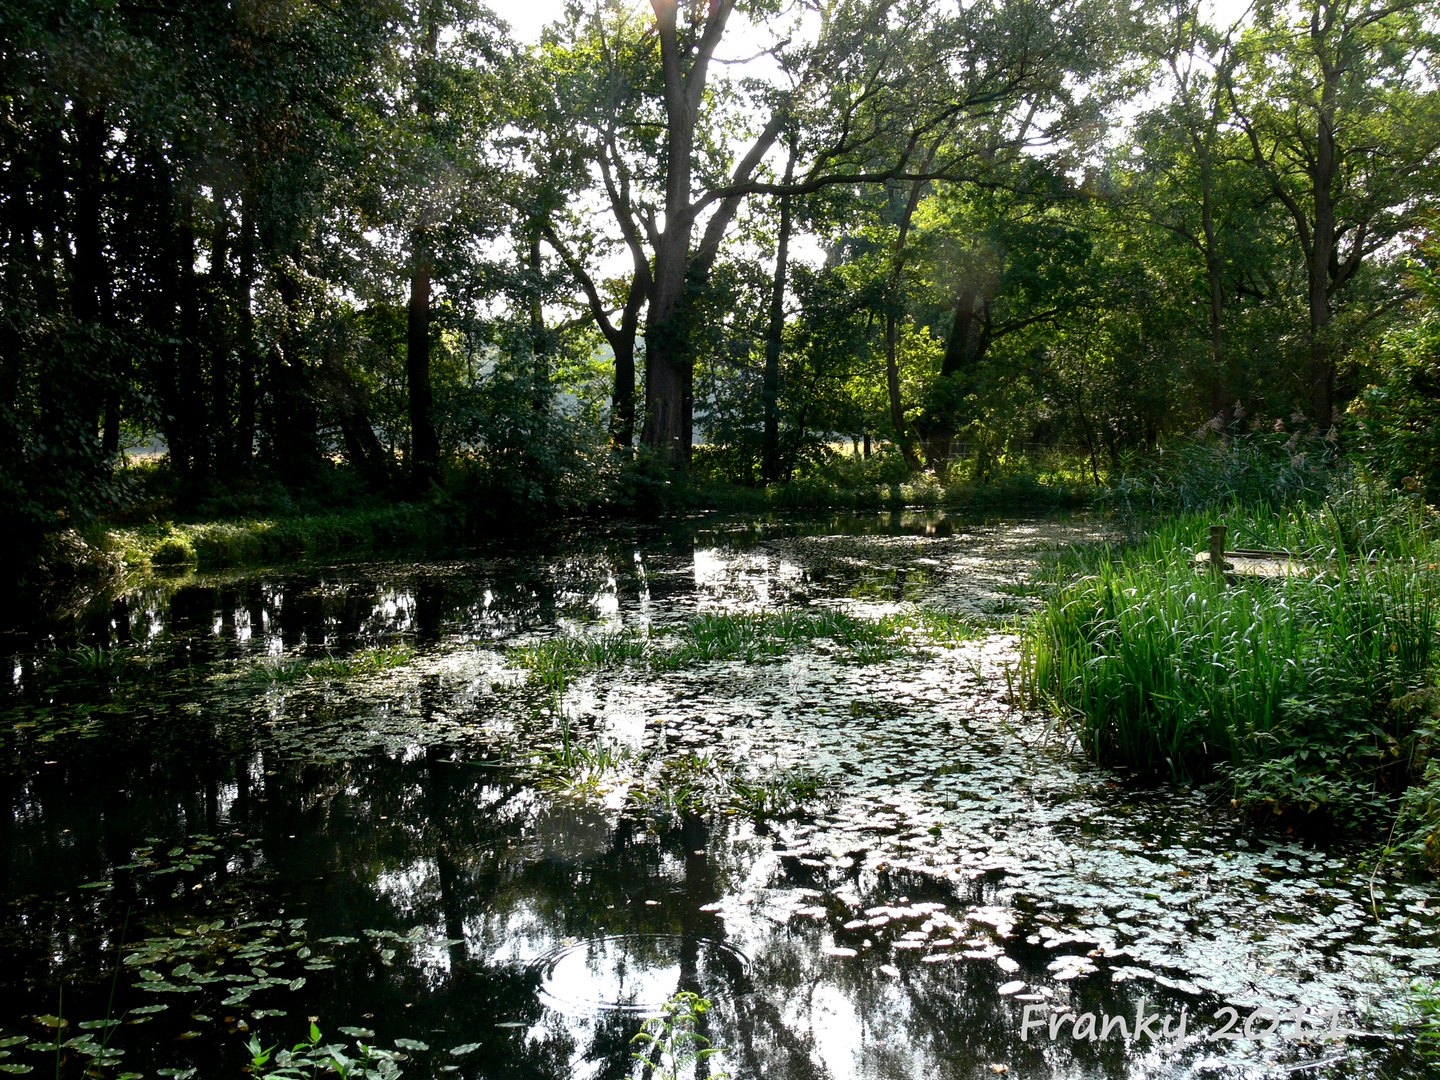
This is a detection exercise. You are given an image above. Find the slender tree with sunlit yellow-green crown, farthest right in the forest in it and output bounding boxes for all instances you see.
[1227,0,1440,426]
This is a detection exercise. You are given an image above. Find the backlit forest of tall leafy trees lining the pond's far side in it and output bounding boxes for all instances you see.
[0,0,1440,578]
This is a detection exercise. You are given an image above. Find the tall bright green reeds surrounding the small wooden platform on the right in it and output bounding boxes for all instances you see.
[1022,490,1440,778]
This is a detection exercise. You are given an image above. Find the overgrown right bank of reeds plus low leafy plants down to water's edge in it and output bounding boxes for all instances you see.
[1022,484,1440,864]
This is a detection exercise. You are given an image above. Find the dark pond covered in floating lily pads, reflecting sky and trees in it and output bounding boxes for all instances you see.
[0,513,1440,1079]
